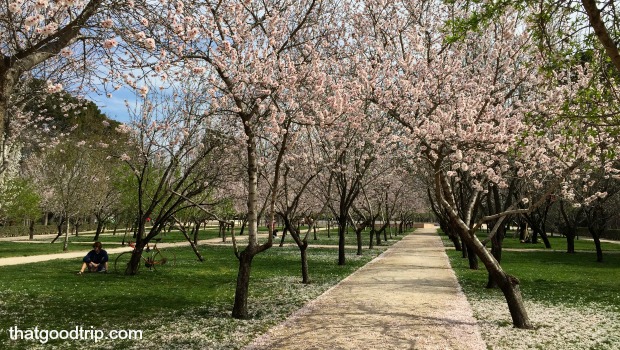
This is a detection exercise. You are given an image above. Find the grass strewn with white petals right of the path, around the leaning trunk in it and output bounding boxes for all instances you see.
[444,231,620,350]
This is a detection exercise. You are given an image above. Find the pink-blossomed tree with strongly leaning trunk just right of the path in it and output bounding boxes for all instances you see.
[360,1,616,328]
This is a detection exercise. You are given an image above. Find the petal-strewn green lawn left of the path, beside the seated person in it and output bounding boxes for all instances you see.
[0,241,388,349]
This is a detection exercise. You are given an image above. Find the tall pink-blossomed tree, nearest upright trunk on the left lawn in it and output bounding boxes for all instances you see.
[109,0,348,318]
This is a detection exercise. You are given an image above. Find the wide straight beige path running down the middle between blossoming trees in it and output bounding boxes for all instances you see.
[248,228,486,350]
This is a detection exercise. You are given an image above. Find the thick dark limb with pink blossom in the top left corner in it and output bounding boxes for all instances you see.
[0,0,121,180]
